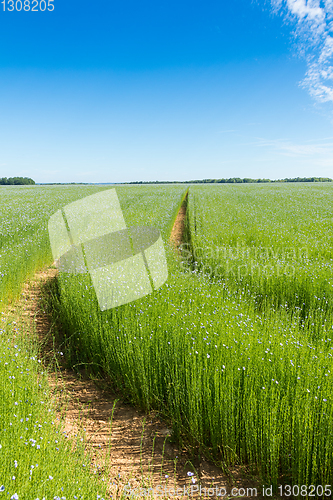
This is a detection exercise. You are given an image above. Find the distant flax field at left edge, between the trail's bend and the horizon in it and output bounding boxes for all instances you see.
[0,186,111,311]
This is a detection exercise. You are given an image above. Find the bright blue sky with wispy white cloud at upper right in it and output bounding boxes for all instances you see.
[0,0,333,182]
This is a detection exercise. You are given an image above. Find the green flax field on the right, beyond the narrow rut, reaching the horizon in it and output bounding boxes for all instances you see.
[184,183,333,324]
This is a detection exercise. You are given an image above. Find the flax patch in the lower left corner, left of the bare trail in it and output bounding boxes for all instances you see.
[0,321,113,500]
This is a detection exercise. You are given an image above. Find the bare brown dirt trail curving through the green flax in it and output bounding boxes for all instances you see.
[3,198,261,499]
